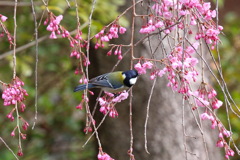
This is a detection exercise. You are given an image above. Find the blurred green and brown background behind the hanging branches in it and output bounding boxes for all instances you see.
[0,0,240,160]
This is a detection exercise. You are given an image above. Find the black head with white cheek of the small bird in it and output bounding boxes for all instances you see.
[122,70,138,87]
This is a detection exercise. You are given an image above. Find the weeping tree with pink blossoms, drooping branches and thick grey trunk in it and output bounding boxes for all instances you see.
[0,0,239,160]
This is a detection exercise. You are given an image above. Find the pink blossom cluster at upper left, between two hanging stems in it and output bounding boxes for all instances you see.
[44,12,70,39]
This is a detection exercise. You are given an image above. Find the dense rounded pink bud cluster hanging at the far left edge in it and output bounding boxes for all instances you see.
[2,78,28,108]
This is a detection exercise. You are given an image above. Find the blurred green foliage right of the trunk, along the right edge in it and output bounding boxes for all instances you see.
[217,12,240,160]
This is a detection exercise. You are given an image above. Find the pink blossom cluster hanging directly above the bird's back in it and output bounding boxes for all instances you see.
[95,23,127,49]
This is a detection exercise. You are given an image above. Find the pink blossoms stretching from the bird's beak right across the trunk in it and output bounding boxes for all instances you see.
[138,43,198,94]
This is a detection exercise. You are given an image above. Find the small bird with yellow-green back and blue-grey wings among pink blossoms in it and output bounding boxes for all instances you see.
[74,70,138,93]
